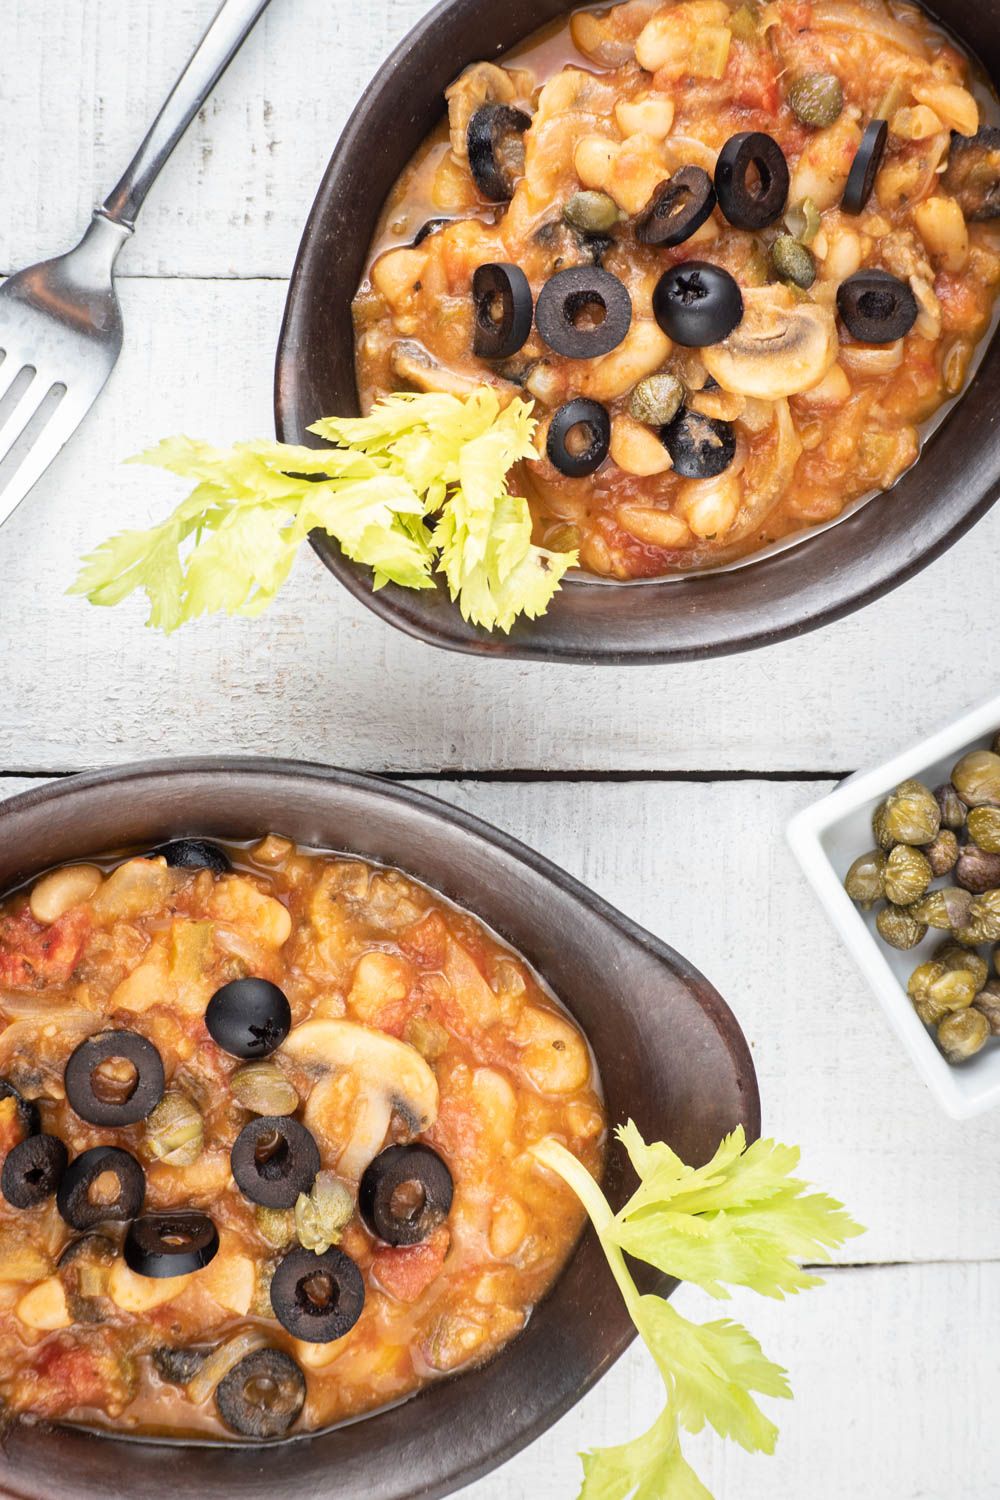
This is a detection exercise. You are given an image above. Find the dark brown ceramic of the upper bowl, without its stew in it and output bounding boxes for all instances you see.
[274,0,1000,663]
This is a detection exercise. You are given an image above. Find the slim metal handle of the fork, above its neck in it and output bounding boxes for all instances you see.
[99,0,270,231]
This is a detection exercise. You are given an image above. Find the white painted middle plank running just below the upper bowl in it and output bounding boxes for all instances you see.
[0,281,1000,771]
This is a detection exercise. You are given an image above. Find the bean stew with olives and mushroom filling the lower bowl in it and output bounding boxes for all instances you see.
[0,836,606,1442]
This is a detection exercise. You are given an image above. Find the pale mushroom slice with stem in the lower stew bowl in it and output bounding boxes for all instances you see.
[283,1020,438,1181]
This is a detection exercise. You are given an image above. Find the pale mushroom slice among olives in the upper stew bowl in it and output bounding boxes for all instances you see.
[702,287,840,401]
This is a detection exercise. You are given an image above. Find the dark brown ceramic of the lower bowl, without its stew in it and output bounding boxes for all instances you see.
[0,759,760,1500]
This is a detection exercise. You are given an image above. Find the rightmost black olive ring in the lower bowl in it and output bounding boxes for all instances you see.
[358,1143,454,1245]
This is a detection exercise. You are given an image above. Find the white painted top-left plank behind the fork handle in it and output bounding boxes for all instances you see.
[0,0,429,276]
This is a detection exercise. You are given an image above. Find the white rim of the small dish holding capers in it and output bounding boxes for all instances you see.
[786,696,1000,1121]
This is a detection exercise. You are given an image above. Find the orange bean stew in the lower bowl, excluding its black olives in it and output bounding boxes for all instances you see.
[0,837,604,1440]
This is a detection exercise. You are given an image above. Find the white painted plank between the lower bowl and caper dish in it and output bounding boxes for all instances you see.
[0,780,1000,1263]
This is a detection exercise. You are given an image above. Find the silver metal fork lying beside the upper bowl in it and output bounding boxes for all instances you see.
[0,0,268,527]
